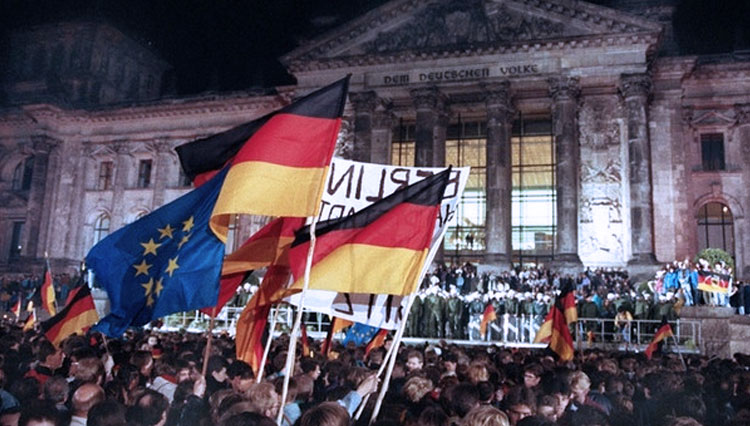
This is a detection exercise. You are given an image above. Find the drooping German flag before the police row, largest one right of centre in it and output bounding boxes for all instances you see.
[534,281,578,361]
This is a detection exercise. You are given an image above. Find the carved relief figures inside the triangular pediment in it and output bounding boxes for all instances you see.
[363,0,565,53]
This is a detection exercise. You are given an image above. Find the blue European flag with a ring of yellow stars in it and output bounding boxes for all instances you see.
[86,169,227,337]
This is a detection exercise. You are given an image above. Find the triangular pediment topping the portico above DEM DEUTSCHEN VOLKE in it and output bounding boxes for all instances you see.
[282,0,661,64]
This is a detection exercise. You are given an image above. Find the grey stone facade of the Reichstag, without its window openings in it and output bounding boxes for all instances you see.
[0,0,750,278]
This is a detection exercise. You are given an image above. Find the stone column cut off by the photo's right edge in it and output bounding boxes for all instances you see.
[732,103,750,278]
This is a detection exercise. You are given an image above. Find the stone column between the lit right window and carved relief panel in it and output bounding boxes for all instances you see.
[548,76,581,268]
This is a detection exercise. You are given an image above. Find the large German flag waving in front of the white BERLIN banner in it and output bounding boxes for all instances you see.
[289,167,451,295]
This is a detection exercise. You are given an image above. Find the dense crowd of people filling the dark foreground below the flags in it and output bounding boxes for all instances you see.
[0,321,750,426]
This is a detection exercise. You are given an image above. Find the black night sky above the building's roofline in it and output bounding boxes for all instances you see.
[0,0,750,94]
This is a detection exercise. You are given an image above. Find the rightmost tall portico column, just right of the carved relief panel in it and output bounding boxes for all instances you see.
[620,74,656,265]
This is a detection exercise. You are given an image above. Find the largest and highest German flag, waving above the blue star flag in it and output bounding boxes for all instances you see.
[177,77,349,240]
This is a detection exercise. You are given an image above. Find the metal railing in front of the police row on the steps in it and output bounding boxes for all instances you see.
[161,305,702,353]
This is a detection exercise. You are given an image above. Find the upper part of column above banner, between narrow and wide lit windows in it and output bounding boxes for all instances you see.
[411,87,446,167]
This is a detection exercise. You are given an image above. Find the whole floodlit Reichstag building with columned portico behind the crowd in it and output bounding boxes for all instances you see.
[0,0,750,278]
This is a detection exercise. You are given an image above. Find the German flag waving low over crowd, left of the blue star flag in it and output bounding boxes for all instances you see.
[41,285,99,346]
